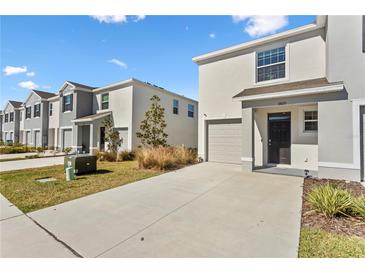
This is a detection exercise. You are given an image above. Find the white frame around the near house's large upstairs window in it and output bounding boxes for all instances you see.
[253,41,290,86]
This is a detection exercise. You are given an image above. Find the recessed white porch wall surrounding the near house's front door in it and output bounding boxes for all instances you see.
[252,105,318,170]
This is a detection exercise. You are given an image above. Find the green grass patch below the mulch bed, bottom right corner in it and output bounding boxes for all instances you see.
[299,228,365,258]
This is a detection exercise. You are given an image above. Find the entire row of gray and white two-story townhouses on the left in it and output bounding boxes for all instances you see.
[2,79,198,154]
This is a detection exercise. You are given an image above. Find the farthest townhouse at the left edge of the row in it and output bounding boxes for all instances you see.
[2,100,22,143]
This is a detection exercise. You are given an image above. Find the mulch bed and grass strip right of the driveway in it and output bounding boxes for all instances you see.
[299,179,365,258]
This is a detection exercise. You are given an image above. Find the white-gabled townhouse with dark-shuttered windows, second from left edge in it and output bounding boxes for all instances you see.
[20,89,55,147]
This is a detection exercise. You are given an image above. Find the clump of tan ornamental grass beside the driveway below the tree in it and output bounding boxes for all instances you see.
[136,146,197,170]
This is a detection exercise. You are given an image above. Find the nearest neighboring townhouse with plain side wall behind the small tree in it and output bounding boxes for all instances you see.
[64,79,198,153]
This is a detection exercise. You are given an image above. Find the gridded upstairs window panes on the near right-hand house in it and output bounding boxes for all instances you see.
[256,47,285,82]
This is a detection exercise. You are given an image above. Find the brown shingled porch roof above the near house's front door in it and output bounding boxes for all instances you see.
[233,78,342,98]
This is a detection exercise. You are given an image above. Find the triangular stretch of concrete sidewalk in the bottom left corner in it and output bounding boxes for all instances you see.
[0,194,76,258]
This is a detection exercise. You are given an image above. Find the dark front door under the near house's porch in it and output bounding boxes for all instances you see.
[268,112,291,164]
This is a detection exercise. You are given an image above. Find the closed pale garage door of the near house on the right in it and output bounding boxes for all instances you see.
[207,119,242,164]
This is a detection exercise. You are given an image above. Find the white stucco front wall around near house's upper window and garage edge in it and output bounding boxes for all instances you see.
[198,29,326,157]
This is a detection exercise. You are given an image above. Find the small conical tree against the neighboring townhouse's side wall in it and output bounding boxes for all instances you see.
[137,95,168,147]
